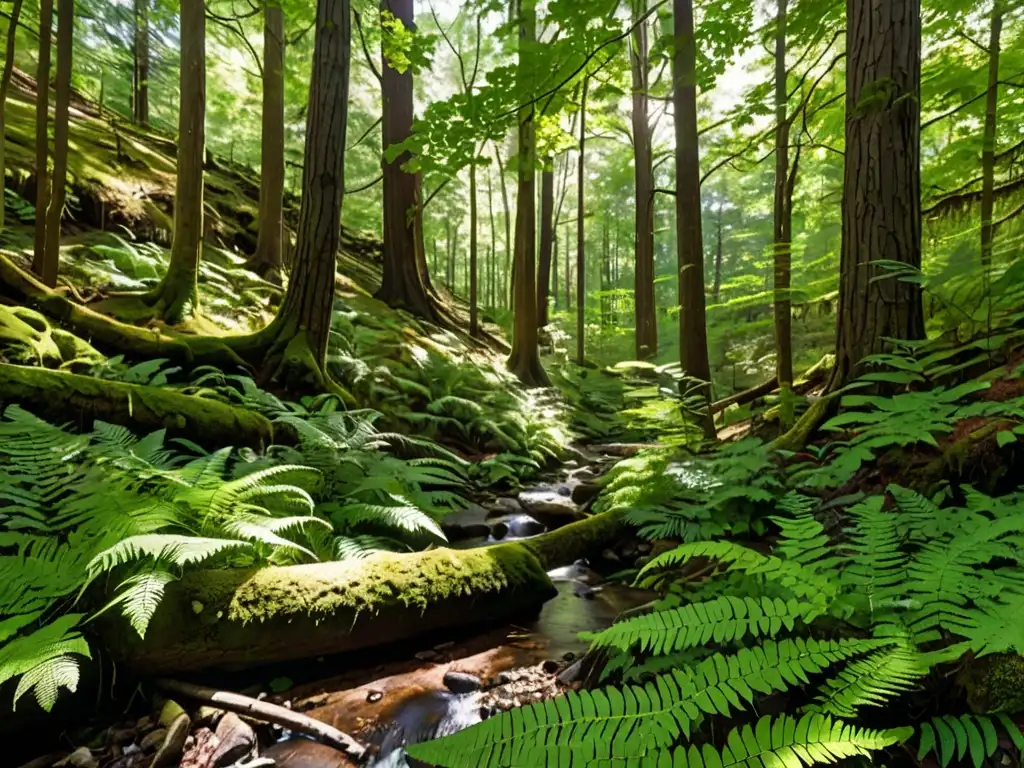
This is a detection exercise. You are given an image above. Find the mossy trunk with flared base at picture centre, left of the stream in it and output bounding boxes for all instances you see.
[508,0,551,387]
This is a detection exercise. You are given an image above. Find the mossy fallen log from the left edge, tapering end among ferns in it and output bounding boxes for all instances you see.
[0,364,297,449]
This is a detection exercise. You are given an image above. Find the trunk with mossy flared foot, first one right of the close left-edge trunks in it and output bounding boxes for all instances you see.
[144,0,204,325]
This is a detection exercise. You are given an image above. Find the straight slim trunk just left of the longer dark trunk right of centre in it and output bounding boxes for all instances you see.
[630,0,657,360]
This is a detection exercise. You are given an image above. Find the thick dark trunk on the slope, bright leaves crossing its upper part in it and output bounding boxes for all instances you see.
[377,0,442,323]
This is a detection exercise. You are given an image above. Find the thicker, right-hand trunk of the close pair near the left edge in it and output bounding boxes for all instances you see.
[39,0,75,288]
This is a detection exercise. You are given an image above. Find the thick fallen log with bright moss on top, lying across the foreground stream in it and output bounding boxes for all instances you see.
[103,545,555,674]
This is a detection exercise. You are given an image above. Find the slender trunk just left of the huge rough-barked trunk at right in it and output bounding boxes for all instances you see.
[772,0,793,415]
